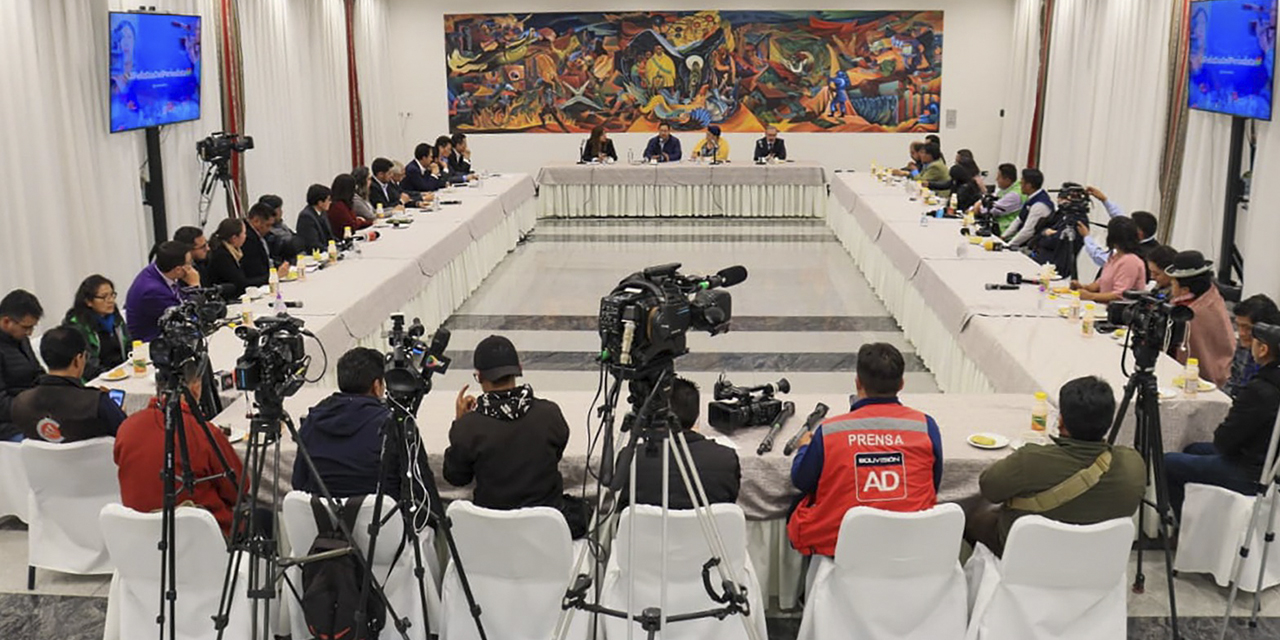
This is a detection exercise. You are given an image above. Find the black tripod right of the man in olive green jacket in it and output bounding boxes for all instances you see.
[1107,330,1179,640]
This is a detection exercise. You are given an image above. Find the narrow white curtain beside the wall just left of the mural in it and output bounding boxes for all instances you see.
[352,0,396,165]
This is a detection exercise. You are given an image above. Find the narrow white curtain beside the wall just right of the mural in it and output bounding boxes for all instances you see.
[1000,0,1042,168]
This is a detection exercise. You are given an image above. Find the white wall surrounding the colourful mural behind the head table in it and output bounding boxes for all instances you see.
[384,0,1016,174]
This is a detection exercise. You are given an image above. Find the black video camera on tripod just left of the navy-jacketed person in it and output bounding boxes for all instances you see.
[234,314,311,403]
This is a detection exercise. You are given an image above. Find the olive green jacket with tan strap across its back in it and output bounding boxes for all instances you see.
[978,438,1147,547]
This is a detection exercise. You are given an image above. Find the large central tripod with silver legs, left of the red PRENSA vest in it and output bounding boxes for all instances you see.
[554,361,763,640]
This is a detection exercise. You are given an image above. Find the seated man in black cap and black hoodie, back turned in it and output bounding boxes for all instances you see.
[443,335,588,539]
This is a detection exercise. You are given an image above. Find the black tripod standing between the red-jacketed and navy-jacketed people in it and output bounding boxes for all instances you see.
[214,388,408,640]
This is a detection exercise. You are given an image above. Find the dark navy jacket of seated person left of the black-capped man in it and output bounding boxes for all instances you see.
[293,393,401,500]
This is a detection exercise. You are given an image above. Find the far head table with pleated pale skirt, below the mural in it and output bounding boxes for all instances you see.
[538,160,828,218]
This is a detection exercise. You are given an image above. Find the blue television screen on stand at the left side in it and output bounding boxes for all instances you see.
[110,12,200,132]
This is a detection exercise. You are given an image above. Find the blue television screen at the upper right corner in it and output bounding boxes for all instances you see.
[1187,0,1276,120]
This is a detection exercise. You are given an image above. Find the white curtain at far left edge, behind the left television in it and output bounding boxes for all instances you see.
[0,0,151,320]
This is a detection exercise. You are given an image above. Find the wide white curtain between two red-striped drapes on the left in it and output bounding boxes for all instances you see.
[237,0,351,213]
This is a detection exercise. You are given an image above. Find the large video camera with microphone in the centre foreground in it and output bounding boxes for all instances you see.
[599,262,746,379]
